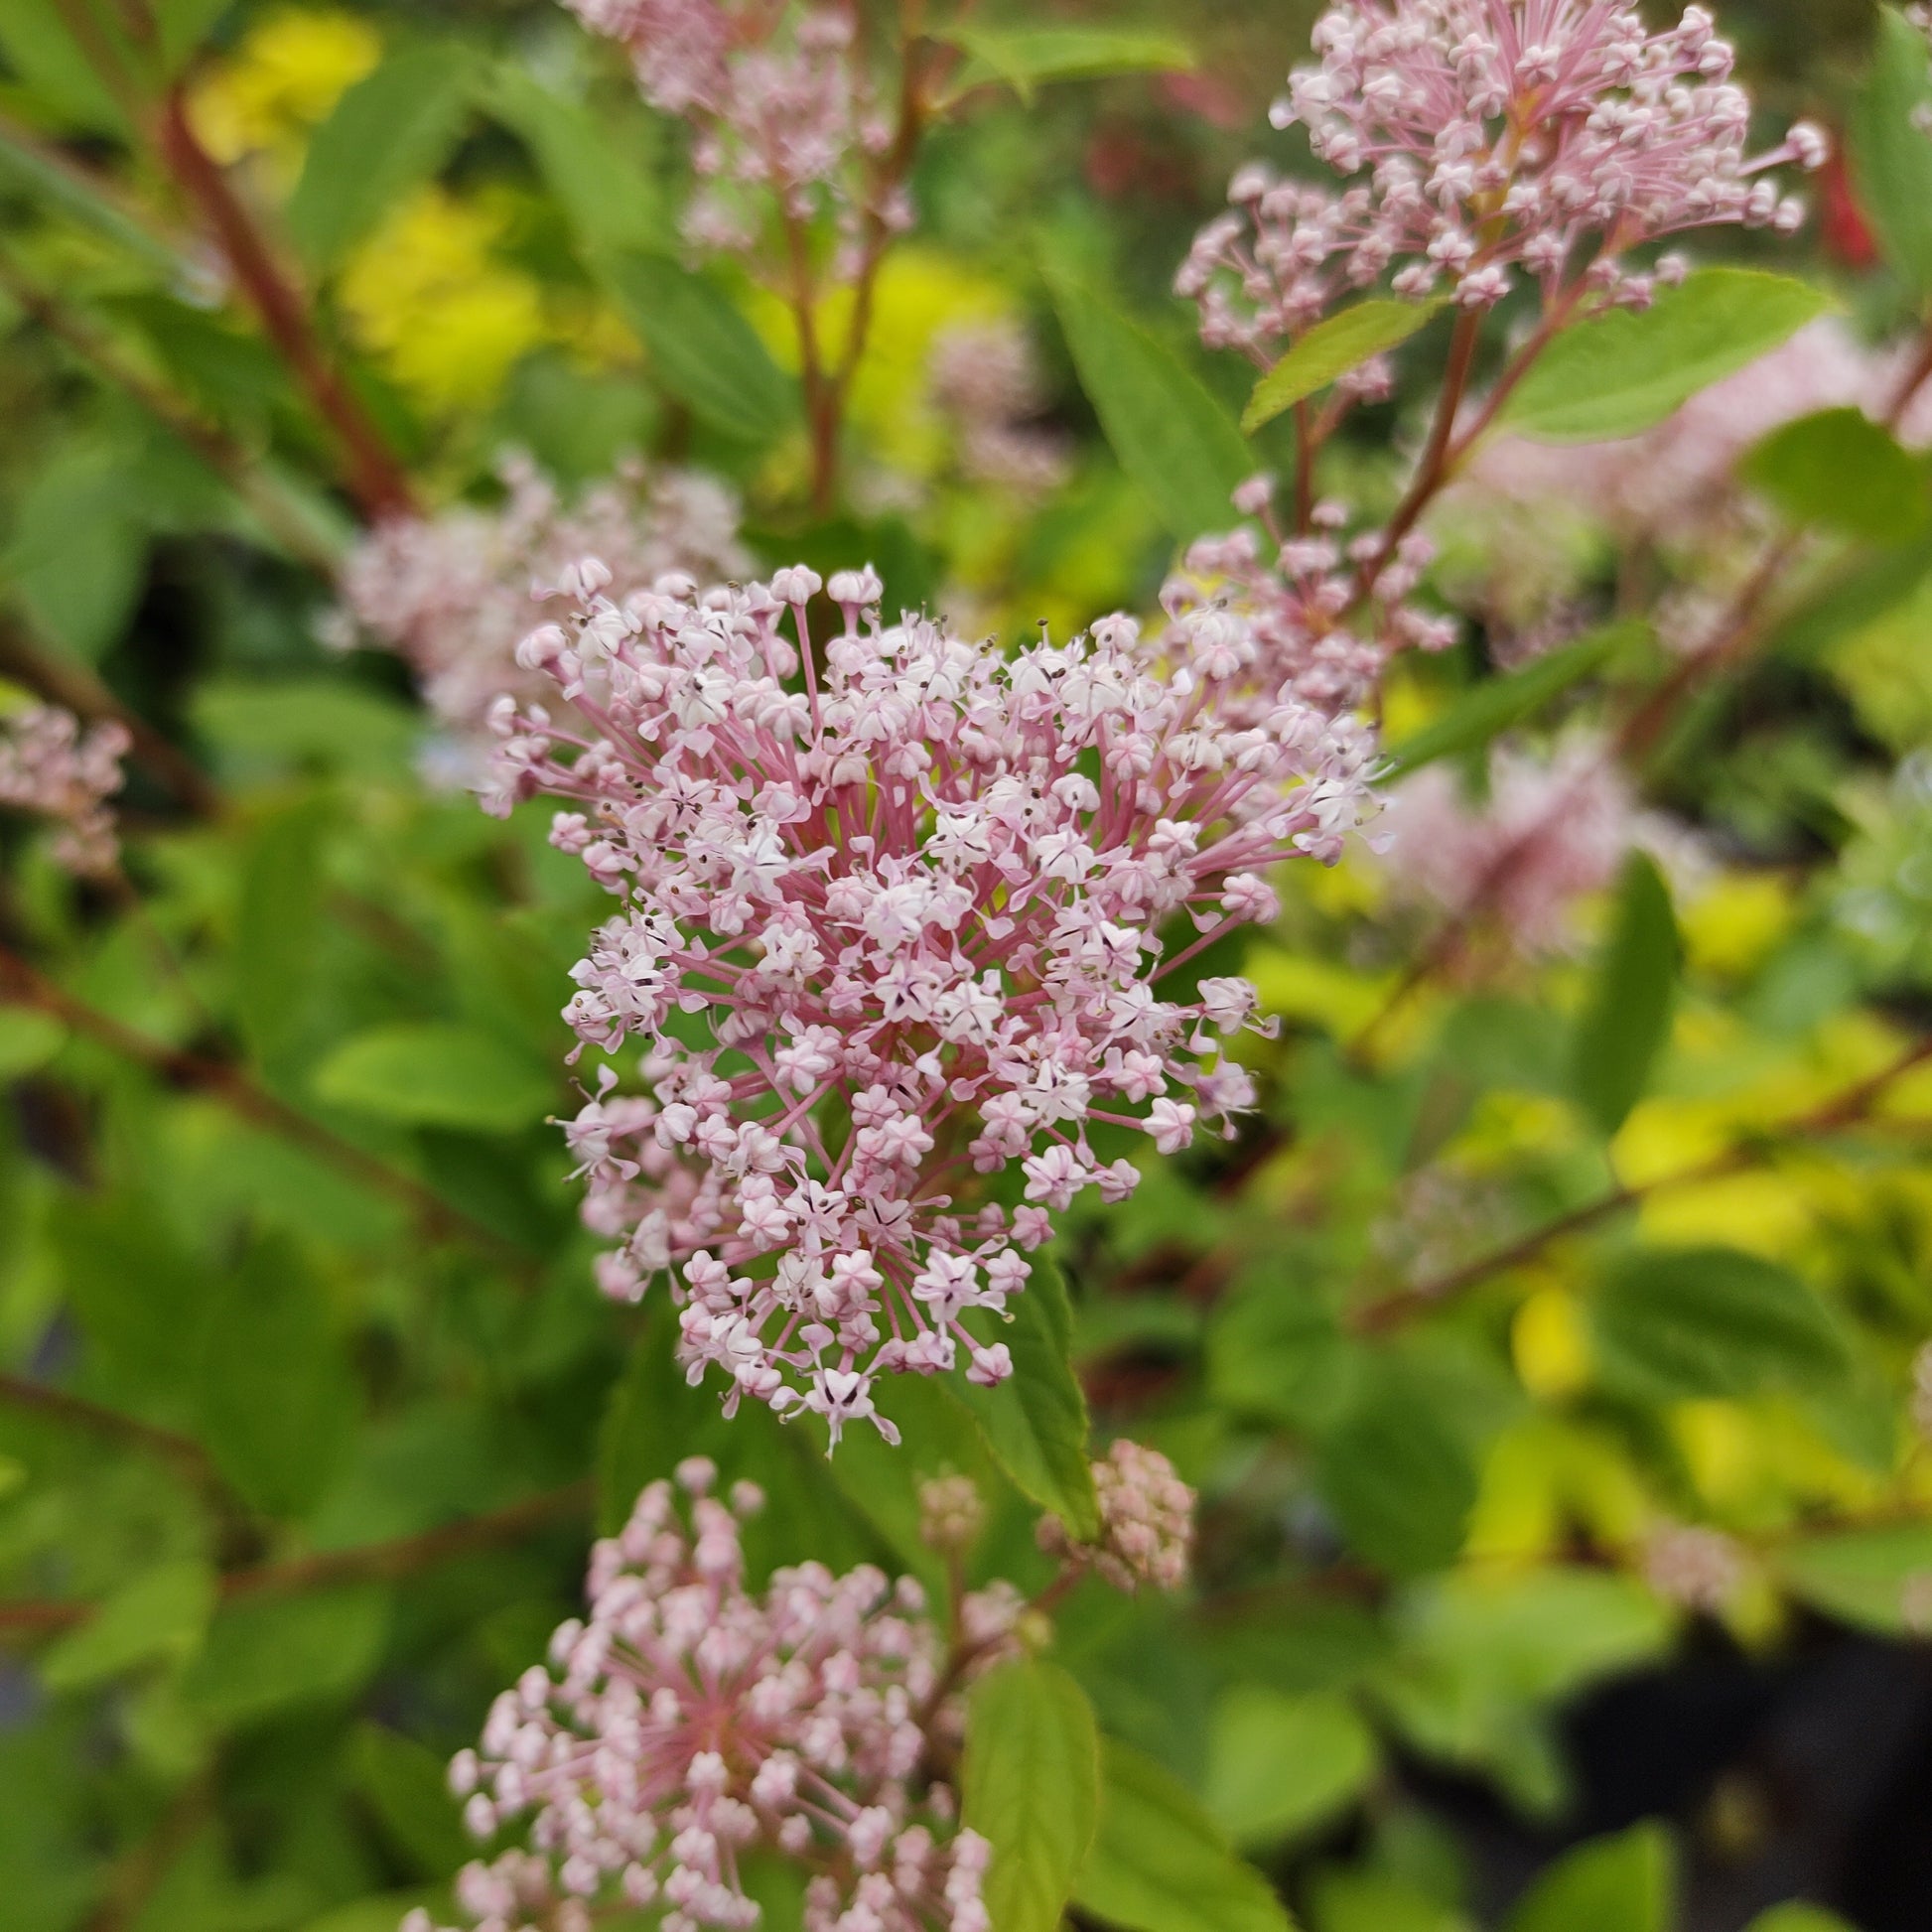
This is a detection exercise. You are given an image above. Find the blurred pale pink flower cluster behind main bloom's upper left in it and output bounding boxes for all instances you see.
[340,456,752,734]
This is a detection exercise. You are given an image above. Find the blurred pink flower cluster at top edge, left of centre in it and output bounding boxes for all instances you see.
[564,0,912,251]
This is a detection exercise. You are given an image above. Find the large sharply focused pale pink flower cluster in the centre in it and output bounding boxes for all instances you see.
[492,560,1376,1436]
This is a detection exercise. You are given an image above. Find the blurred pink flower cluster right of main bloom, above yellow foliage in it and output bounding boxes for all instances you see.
[1385,740,1638,954]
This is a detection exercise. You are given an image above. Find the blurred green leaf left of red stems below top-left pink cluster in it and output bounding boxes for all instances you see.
[593,249,798,443]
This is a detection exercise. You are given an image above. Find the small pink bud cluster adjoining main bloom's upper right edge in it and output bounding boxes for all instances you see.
[1160,486,1456,717]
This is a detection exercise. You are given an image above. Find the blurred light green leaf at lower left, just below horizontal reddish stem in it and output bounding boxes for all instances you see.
[182,1585,388,1729]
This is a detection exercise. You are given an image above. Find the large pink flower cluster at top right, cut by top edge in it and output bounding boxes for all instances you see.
[1176,0,1826,361]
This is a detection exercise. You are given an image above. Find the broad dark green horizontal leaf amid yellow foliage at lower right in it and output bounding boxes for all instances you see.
[1590,1248,1849,1401]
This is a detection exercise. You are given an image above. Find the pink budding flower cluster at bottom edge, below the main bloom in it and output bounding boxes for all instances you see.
[404,1456,991,1932]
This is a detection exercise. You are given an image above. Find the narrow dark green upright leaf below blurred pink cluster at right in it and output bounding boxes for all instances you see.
[1571,852,1679,1138]
